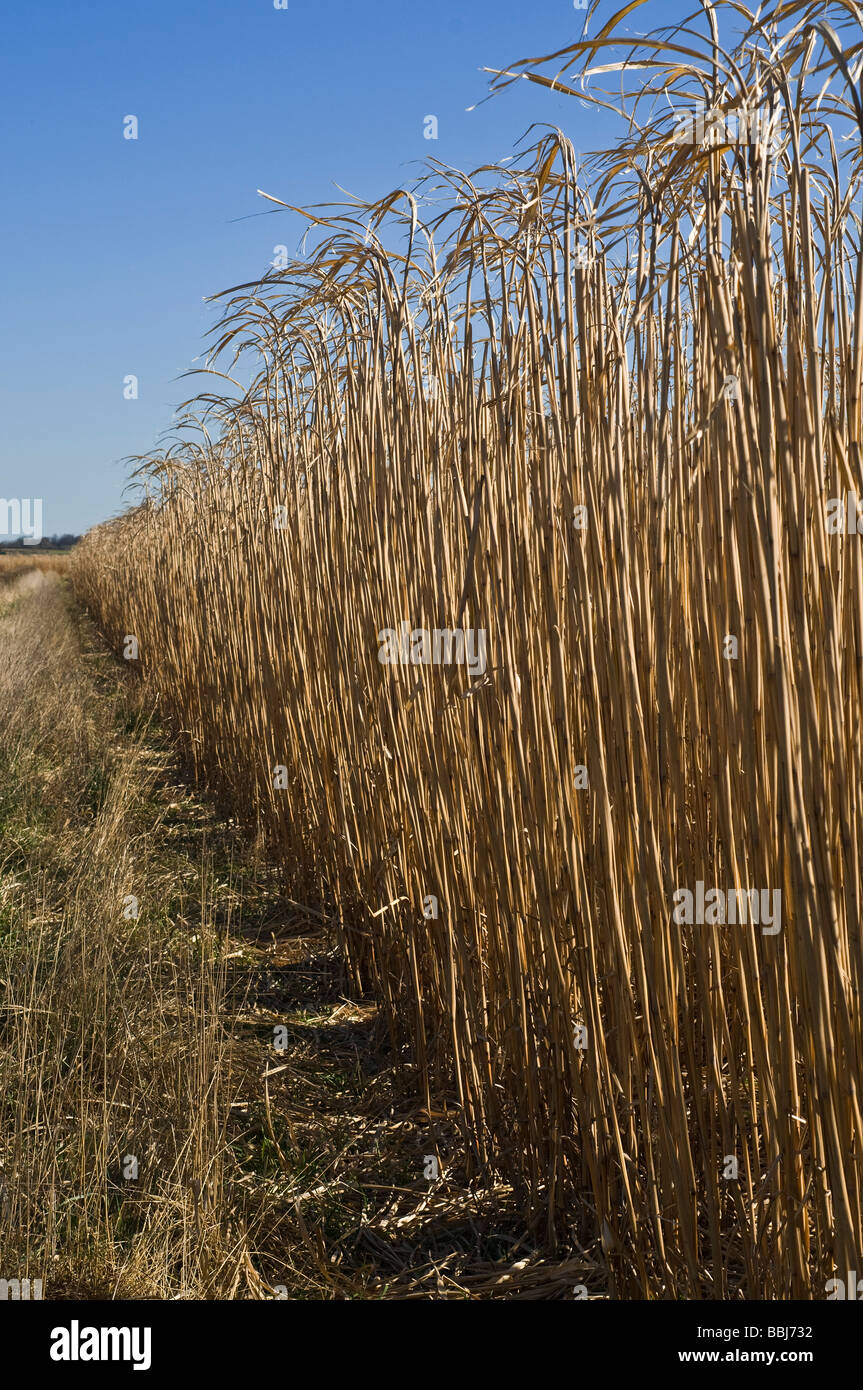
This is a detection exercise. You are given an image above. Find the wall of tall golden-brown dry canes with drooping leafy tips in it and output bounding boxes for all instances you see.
[74,3,863,1298]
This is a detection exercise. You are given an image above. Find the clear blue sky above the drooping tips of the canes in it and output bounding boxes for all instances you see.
[0,0,686,535]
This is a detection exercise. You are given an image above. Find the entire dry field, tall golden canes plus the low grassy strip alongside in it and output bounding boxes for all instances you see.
[0,0,863,1300]
